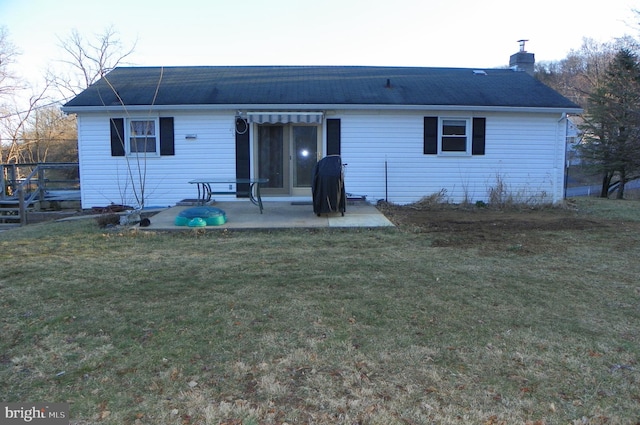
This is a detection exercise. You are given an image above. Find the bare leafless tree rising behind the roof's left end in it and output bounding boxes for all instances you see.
[48,26,136,99]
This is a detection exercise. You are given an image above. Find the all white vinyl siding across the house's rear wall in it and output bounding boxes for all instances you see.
[78,110,565,208]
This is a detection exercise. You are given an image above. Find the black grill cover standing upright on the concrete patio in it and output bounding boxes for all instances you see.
[311,155,347,215]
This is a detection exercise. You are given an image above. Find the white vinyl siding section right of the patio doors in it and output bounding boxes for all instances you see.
[341,112,564,204]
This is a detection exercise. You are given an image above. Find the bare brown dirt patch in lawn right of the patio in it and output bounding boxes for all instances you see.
[378,204,612,253]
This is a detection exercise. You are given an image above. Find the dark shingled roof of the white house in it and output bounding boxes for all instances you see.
[64,66,579,109]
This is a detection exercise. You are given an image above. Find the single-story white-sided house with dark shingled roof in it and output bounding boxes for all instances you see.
[63,51,580,207]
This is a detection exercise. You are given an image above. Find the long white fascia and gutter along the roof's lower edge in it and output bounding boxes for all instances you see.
[62,104,583,114]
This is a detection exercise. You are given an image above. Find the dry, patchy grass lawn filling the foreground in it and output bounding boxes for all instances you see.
[0,199,640,425]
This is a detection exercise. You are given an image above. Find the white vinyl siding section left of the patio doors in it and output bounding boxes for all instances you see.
[78,112,236,208]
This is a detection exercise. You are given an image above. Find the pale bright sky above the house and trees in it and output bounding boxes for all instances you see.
[0,0,640,88]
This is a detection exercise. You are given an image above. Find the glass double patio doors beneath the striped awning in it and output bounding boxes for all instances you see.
[256,125,320,196]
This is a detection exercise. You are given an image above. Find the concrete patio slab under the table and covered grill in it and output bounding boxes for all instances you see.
[140,200,393,231]
